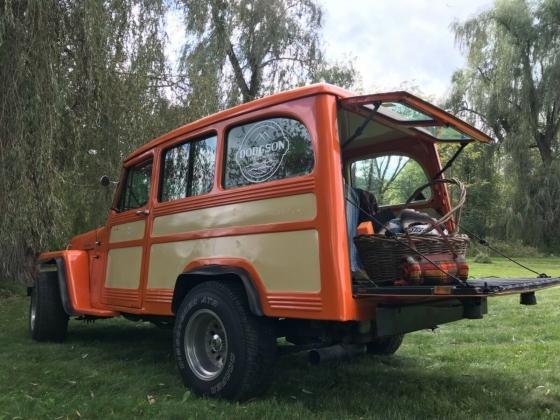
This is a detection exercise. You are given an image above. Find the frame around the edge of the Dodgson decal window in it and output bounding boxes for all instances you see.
[219,112,317,191]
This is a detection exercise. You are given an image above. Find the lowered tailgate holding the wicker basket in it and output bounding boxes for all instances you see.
[353,277,560,297]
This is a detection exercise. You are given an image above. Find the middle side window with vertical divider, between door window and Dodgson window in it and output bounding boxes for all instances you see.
[160,136,216,201]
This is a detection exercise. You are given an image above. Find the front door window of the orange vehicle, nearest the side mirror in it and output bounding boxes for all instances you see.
[118,160,152,211]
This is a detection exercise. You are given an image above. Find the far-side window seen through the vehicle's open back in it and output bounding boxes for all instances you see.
[351,155,431,206]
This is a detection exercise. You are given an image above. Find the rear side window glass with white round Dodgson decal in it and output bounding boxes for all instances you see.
[224,118,314,188]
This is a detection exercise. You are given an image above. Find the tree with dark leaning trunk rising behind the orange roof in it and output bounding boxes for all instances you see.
[179,0,355,112]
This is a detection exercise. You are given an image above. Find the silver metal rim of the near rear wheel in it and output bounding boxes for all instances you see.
[184,309,228,381]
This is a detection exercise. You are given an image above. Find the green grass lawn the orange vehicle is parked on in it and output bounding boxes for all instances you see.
[0,258,560,419]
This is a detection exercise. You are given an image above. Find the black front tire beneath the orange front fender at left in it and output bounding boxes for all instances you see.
[29,273,68,342]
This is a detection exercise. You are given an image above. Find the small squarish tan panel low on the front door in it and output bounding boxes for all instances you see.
[105,246,142,289]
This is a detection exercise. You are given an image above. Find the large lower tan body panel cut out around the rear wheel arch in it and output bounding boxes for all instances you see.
[148,230,321,292]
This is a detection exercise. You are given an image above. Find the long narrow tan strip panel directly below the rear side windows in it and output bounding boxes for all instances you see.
[152,194,317,236]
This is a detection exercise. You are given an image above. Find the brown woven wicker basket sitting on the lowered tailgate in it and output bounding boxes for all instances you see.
[354,235,469,284]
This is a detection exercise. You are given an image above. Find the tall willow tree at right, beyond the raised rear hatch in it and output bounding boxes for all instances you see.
[450,0,560,247]
